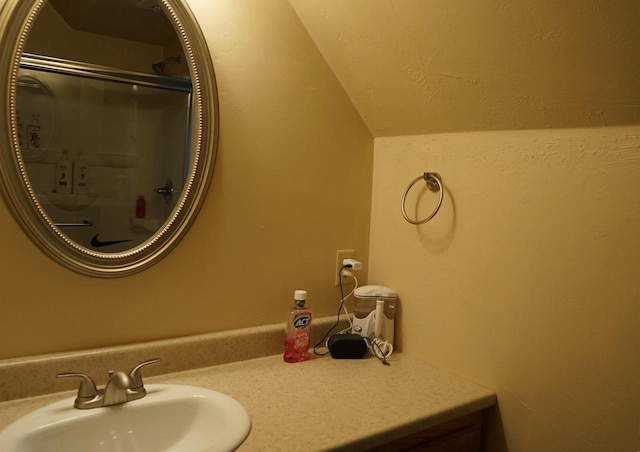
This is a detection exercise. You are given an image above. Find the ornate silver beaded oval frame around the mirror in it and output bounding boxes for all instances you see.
[0,0,218,278]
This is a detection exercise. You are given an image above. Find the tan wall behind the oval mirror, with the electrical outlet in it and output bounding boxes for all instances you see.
[0,0,373,358]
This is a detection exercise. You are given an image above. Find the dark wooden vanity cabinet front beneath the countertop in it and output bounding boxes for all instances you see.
[371,410,486,452]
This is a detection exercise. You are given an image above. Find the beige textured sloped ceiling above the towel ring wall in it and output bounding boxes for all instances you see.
[289,0,640,136]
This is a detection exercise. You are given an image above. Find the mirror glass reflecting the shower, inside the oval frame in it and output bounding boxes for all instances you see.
[16,0,192,253]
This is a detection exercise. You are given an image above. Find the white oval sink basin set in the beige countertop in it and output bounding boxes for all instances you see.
[0,385,251,452]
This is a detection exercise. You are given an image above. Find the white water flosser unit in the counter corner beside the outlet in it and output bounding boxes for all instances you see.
[352,285,398,345]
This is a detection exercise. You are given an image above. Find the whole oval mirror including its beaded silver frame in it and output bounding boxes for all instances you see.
[0,0,218,277]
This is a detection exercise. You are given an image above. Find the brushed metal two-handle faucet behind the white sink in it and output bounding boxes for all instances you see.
[57,358,160,410]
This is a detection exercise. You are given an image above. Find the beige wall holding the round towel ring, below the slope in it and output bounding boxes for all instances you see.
[369,126,640,452]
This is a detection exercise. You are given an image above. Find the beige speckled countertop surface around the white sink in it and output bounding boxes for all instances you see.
[0,320,496,451]
